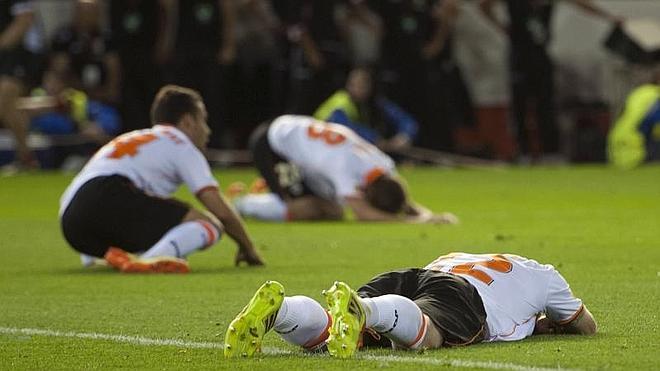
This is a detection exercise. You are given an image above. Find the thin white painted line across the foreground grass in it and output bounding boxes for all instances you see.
[0,327,575,371]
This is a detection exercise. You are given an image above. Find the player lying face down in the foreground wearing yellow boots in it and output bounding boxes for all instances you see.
[224,253,596,358]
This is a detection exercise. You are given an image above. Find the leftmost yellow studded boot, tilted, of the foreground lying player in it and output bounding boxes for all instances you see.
[225,281,284,358]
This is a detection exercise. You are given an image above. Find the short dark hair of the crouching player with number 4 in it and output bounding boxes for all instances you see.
[151,85,204,125]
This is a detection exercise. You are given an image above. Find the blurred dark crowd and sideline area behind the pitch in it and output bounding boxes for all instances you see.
[0,0,660,167]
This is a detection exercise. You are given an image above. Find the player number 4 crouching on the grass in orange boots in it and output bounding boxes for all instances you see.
[60,85,263,273]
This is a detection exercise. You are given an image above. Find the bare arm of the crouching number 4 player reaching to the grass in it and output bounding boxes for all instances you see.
[197,188,264,265]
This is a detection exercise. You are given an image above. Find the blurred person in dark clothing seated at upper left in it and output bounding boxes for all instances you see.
[49,0,121,105]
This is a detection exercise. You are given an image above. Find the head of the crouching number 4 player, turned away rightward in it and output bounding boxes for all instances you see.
[151,85,211,149]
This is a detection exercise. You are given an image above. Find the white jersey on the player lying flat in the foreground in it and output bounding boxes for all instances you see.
[425,253,582,341]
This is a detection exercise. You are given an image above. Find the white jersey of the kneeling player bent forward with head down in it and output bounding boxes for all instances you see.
[268,115,395,203]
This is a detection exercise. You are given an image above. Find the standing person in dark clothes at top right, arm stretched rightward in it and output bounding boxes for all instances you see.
[480,0,621,157]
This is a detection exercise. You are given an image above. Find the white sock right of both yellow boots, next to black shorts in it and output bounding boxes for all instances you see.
[361,295,427,349]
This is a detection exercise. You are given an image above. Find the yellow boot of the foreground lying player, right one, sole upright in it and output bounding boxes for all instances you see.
[323,281,366,358]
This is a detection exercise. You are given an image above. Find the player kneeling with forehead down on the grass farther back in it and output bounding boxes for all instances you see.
[229,115,458,224]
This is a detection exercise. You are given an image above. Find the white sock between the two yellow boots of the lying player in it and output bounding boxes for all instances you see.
[273,296,331,349]
